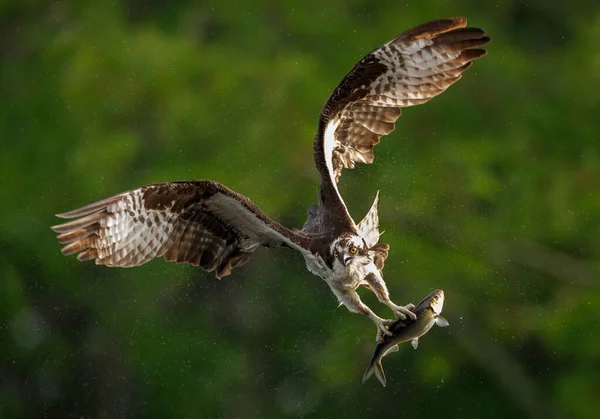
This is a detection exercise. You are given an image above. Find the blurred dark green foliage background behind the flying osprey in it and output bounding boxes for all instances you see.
[0,0,600,418]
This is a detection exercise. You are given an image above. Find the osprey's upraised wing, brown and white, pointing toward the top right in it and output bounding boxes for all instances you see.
[315,17,490,227]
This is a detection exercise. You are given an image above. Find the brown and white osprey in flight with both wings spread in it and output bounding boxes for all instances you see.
[52,17,489,339]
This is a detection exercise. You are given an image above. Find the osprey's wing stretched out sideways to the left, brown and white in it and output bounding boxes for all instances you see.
[52,181,304,278]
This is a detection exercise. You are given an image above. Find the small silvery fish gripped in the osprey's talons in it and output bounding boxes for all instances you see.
[362,290,449,387]
